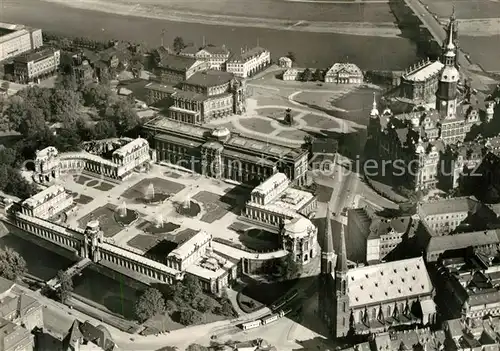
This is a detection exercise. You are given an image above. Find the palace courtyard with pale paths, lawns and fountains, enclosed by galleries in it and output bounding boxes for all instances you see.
[57,165,270,254]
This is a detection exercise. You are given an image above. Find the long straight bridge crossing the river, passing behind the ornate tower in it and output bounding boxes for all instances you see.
[405,0,484,90]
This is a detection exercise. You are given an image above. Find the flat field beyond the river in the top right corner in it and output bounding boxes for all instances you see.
[422,0,500,19]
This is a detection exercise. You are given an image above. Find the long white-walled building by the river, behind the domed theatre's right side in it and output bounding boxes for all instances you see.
[226,47,271,78]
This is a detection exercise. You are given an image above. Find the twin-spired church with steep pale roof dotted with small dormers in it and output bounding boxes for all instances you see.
[318,210,437,338]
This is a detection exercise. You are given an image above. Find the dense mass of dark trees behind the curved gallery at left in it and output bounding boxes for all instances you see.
[0,71,141,199]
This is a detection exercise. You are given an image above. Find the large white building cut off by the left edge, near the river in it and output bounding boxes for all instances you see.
[0,23,43,61]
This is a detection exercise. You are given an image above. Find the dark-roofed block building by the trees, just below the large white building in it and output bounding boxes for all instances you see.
[14,49,61,83]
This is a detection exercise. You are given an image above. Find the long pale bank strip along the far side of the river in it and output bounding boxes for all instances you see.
[43,0,401,37]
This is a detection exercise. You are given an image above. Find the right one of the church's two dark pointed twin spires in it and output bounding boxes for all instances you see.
[333,224,351,338]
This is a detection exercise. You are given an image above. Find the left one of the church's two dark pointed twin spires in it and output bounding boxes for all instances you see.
[318,205,335,330]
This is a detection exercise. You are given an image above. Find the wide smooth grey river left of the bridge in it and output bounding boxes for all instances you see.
[0,0,417,70]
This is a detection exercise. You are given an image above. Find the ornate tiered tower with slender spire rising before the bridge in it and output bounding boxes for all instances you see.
[436,12,460,119]
